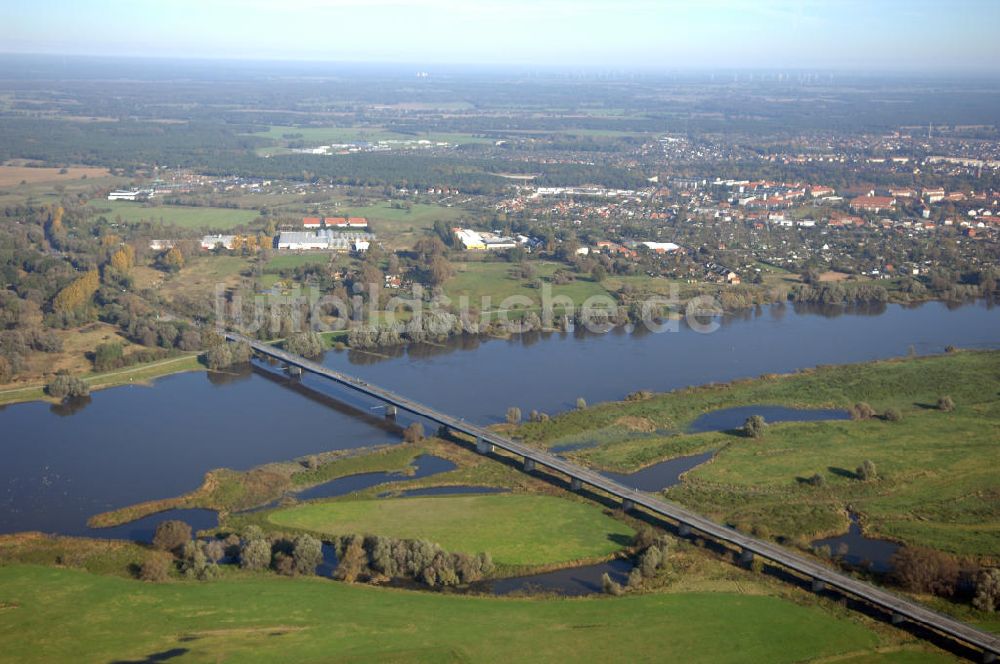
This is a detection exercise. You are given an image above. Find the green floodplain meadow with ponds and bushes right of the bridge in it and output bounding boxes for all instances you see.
[520,352,1000,556]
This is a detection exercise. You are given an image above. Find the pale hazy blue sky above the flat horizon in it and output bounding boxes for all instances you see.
[7,0,1000,72]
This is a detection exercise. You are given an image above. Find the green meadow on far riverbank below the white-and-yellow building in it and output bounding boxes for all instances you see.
[444,261,608,310]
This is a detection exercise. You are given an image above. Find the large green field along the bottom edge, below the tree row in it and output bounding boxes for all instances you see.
[0,566,952,664]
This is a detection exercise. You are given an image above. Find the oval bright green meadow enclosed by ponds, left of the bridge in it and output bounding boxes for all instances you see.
[268,494,632,566]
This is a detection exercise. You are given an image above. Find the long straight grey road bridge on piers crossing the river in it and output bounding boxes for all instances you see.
[226,333,1000,663]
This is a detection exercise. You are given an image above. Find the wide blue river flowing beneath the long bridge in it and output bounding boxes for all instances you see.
[0,303,1000,534]
